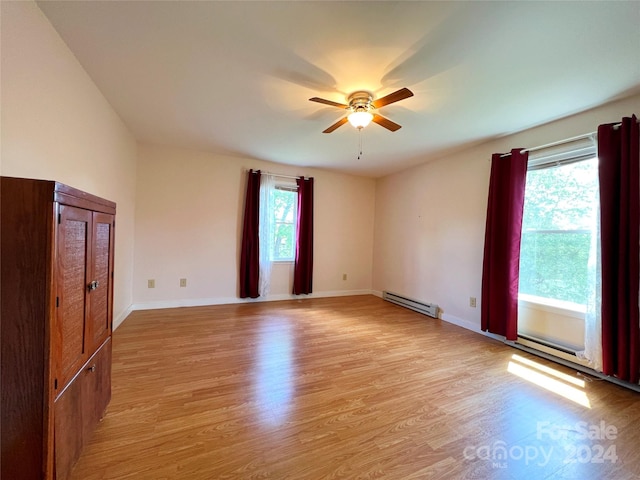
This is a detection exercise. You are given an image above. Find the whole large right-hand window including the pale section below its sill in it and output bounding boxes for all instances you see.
[519,140,599,348]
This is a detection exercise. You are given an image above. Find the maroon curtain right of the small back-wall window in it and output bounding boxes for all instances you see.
[293,177,313,295]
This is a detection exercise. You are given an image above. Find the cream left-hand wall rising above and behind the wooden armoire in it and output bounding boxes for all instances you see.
[0,1,136,326]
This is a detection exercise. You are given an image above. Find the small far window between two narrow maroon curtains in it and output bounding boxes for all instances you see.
[272,185,298,262]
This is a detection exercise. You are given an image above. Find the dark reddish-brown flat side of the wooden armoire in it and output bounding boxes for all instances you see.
[0,177,53,479]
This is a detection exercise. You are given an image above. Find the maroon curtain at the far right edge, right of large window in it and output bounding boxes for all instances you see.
[598,115,640,383]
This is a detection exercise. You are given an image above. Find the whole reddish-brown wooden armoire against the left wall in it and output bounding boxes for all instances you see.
[0,177,116,480]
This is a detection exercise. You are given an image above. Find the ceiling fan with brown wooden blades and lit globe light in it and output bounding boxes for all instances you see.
[309,88,413,133]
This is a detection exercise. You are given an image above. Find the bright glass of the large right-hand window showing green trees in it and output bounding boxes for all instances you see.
[520,158,598,305]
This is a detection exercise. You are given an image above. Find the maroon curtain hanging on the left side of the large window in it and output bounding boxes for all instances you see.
[481,148,529,340]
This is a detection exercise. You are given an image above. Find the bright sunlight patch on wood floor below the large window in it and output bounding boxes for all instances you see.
[507,354,591,408]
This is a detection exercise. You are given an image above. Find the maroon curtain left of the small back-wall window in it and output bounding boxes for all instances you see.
[240,170,260,298]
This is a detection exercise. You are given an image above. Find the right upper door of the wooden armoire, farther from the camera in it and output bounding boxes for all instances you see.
[89,212,114,347]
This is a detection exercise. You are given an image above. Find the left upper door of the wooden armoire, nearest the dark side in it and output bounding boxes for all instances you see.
[56,205,91,388]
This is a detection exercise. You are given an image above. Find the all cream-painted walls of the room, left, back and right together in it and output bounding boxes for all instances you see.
[5,1,640,329]
